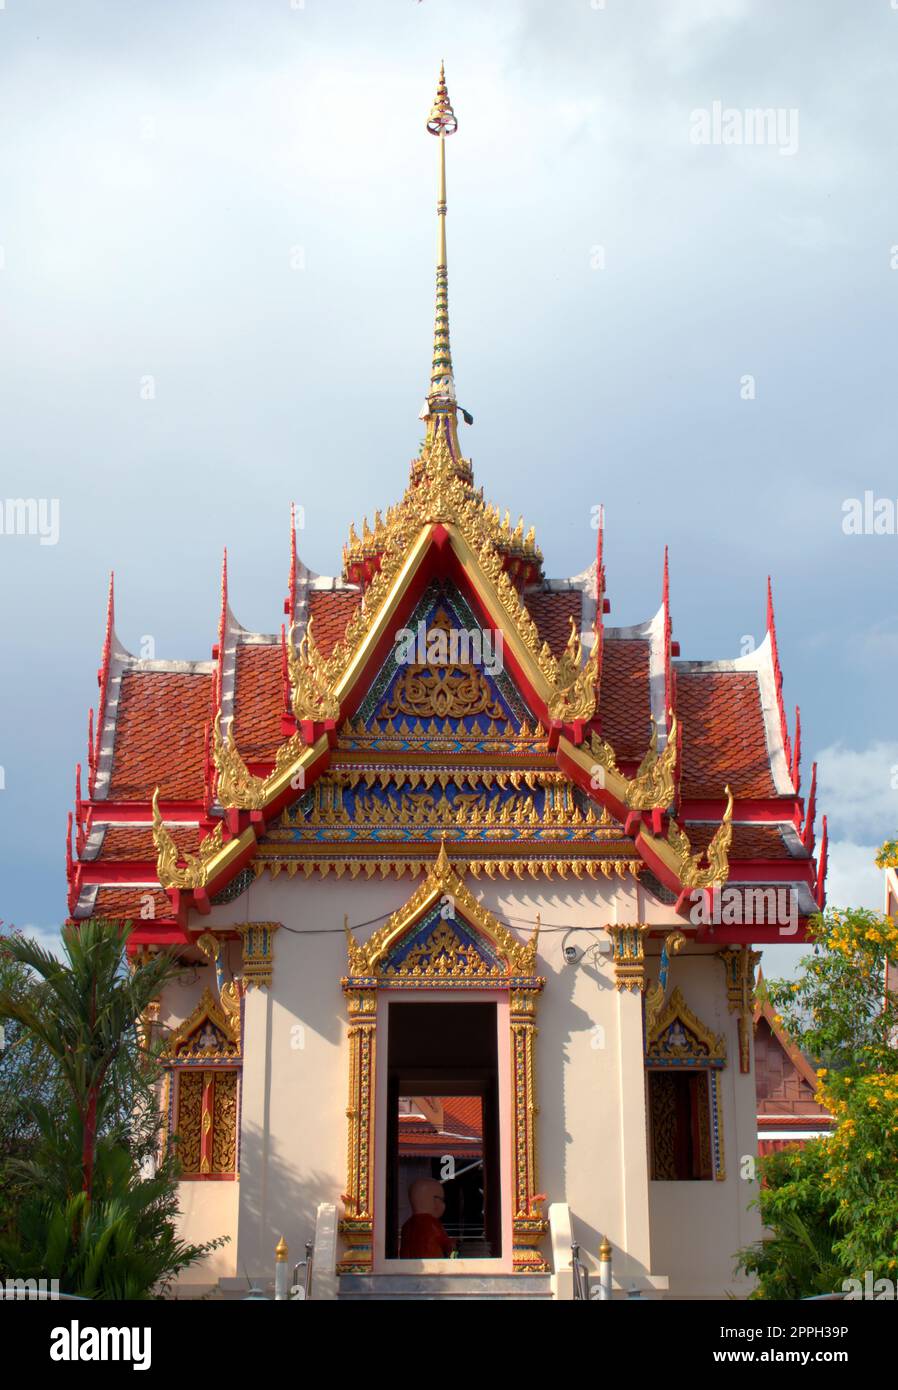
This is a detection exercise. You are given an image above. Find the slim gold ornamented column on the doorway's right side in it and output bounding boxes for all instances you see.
[510,988,549,1273]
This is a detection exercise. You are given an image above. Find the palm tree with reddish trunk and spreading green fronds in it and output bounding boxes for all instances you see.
[0,920,181,1204]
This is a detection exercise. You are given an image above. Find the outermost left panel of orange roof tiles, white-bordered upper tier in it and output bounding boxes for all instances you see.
[108,671,213,801]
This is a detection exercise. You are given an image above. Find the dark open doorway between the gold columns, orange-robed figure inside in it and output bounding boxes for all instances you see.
[385,1002,502,1259]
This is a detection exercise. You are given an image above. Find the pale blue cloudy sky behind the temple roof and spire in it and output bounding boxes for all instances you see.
[0,0,898,949]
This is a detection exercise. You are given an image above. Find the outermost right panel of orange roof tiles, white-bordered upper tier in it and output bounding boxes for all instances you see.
[678,671,776,798]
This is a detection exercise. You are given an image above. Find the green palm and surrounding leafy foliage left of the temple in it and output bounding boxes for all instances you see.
[0,922,224,1298]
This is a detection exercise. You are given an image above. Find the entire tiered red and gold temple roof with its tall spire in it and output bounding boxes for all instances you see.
[67,74,826,941]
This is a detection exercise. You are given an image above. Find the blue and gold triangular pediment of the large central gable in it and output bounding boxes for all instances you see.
[256,578,639,877]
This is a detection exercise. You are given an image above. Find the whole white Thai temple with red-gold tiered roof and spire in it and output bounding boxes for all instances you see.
[68,71,826,1298]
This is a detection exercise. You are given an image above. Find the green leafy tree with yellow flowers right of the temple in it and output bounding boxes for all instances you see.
[738,908,898,1298]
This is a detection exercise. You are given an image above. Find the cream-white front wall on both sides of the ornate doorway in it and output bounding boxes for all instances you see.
[167,873,760,1295]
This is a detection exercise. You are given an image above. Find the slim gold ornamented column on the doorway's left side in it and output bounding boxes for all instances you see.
[338,980,377,1275]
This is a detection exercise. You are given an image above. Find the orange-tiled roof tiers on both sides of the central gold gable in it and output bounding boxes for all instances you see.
[70,528,823,926]
